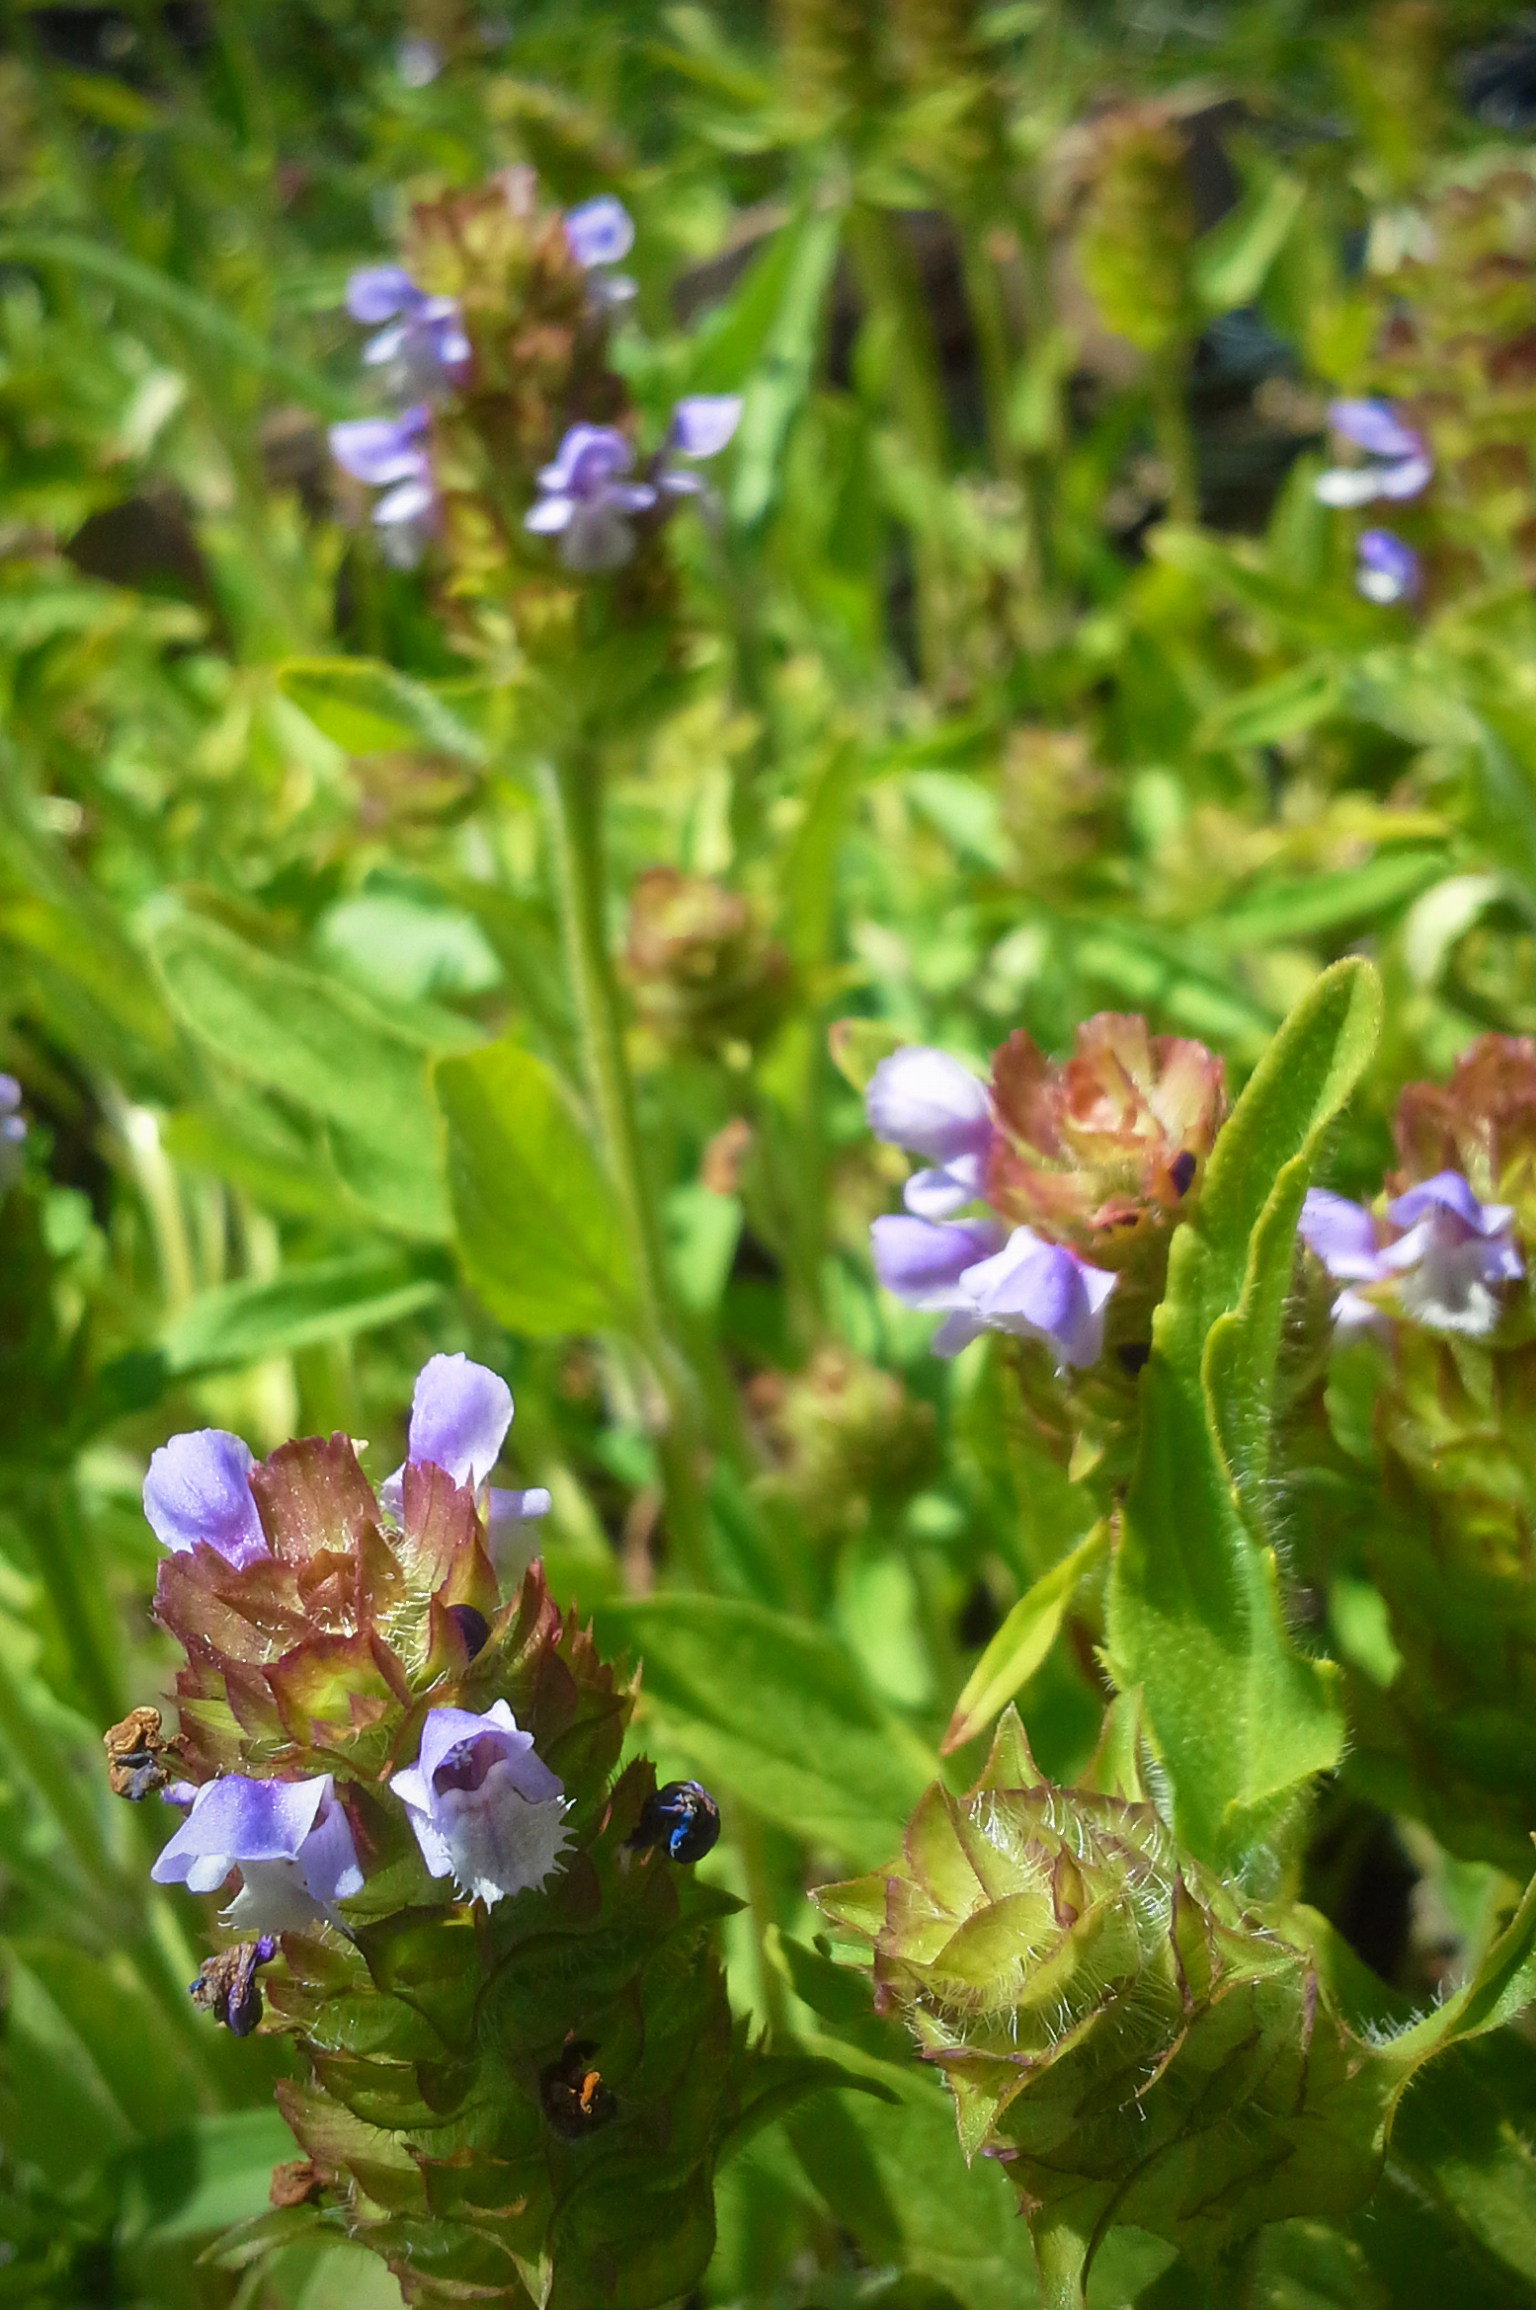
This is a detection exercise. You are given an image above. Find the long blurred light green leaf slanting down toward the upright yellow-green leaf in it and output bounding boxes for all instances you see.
[150,915,461,1238]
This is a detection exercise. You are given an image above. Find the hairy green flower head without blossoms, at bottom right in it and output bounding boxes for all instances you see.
[818,1702,1536,2305]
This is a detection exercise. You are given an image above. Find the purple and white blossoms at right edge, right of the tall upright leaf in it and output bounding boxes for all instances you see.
[1300,1171,1524,1340]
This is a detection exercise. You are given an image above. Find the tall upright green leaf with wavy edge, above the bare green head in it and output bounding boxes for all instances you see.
[1109,961,1381,1866]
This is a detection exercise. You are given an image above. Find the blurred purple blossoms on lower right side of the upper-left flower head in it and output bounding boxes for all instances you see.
[524,393,741,578]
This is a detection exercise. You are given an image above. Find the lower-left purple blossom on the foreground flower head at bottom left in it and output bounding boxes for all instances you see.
[150,1772,363,1933]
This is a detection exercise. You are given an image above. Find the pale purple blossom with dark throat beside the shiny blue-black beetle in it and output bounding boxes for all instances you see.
[390,1700,566,1908]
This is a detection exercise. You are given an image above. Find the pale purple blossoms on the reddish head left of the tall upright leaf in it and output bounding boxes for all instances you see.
[866,1046,1116,1370]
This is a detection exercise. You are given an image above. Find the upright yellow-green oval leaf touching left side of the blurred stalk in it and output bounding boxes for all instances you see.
[437,1042,635,1340]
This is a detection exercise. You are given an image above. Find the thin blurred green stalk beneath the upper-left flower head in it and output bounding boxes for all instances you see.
[545,742,711,1587]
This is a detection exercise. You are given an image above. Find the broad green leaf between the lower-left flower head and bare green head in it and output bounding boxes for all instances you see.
[596,1596,935,1866]
